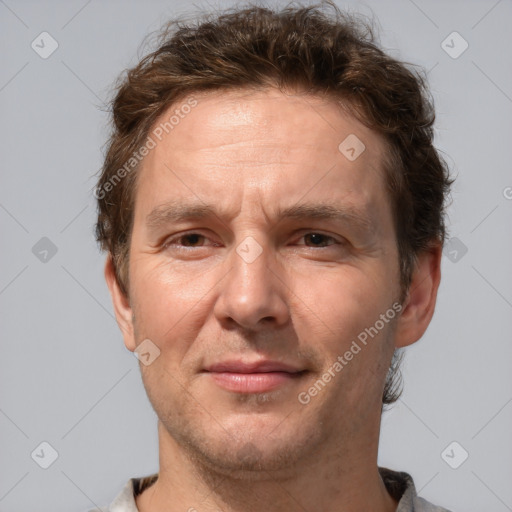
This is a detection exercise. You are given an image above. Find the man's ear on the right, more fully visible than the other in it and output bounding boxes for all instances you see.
[395,244,442,348]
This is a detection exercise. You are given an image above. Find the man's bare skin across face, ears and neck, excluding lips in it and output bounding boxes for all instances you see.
[105,89,441,512]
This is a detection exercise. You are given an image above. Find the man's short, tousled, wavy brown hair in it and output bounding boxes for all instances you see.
[95,0,451,404]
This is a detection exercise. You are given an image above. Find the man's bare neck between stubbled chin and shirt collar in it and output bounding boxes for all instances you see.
[136,422,397,512]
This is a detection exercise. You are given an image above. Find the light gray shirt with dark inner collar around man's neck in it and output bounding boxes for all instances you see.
[89,468,450,512]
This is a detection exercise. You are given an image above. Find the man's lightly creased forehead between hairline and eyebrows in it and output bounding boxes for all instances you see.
[136,89,387,220]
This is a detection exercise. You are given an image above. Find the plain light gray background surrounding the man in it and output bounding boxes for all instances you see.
[0,0,512,512]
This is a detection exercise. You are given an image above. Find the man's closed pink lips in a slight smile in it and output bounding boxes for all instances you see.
[203,361,307,393]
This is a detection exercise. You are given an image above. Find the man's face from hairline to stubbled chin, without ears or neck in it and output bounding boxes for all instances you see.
[118,90,400,469]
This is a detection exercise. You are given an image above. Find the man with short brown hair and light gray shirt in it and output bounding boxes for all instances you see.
[95,3,450,512]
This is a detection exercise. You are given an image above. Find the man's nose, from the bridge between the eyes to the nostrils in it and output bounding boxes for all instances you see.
[214,237,289,331]
